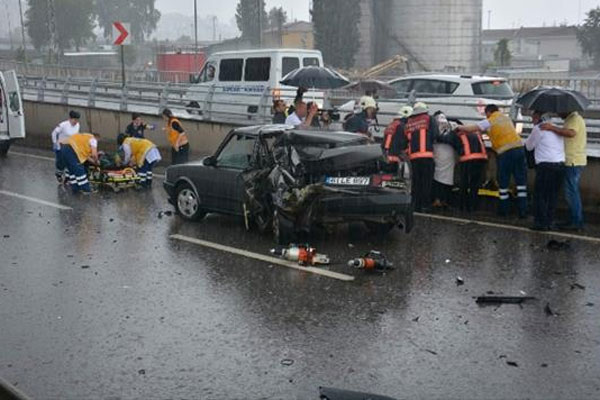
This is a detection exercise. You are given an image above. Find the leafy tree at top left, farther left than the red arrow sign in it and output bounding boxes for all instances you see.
[25,0,95,50]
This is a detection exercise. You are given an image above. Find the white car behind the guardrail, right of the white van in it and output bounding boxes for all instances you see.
[339,74,522,138]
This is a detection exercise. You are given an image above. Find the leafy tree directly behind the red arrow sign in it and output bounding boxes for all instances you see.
[94,0,160,43]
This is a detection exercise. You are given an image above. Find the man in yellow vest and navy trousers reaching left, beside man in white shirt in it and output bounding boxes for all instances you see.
[457,104,527,219]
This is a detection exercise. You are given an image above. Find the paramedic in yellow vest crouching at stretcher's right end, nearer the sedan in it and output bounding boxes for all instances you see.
[117,133,162,188]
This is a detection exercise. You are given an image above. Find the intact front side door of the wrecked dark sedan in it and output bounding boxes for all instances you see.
[207,133,256,214]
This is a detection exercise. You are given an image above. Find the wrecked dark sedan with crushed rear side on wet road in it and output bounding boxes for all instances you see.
[164,125,413,244]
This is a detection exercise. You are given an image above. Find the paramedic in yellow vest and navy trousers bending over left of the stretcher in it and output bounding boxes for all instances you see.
[61,133,99,194]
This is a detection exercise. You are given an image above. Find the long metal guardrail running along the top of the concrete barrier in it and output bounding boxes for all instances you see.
[15,76,600,143]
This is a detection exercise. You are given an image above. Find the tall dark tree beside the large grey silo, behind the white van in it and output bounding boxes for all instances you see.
[310,0,360,68]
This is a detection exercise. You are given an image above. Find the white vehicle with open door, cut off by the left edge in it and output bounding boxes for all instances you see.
[0,71,25,156]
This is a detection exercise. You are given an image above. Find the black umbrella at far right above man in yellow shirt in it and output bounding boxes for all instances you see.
[517,87,590,114]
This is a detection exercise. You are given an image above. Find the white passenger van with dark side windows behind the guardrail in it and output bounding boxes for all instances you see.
[184,49,323,122]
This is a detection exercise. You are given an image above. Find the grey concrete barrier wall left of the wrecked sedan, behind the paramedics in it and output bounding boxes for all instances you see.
[23,101,237,162]
